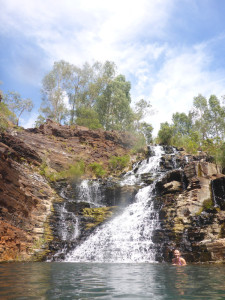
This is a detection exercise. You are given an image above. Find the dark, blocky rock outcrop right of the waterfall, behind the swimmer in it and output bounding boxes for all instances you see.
[153,153,225,262]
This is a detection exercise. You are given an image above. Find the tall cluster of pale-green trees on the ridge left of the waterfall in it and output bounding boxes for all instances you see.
[39,60,152,135]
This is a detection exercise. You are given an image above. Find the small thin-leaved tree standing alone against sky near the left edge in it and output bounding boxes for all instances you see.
[3,91,34,125]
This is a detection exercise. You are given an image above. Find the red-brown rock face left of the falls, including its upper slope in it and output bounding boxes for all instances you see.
[0,121,133,261]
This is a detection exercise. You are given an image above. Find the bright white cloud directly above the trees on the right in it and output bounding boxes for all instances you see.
[149,44,225,132]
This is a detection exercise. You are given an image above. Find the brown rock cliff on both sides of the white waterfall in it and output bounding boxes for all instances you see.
[0,120,225,262]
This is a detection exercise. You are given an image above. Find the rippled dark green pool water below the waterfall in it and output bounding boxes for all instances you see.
[0,263,225,300]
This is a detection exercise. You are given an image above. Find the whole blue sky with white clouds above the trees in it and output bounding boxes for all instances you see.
[0,0,225,134]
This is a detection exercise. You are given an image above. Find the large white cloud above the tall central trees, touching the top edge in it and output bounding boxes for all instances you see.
[0,0,173,63]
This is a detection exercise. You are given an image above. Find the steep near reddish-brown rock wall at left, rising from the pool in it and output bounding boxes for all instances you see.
[0,145,56,261]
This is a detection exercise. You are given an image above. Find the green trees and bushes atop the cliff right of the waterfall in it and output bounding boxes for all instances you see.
[157,95,225,172]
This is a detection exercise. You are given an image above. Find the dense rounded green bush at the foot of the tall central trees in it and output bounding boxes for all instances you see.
[76,107,102,129]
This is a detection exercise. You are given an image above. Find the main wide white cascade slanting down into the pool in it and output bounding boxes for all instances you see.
[65,146,163,262]
